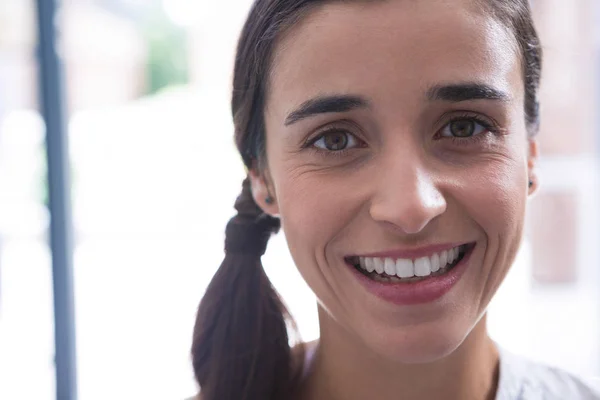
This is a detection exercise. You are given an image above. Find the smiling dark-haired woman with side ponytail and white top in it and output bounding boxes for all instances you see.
[192,0,600,400]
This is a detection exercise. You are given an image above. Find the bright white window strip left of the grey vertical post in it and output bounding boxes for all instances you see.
[0,0,55,400]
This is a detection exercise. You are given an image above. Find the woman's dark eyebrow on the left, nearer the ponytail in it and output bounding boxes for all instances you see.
[285,95,369,126]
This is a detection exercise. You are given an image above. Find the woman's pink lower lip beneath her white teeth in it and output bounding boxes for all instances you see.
[347,247,474,305]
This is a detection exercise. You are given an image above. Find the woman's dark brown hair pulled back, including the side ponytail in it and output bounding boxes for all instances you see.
[192,0,542,400]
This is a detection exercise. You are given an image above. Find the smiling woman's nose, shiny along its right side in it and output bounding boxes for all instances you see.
[370,155,447,234]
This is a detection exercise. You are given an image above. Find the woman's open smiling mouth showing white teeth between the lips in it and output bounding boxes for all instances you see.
[346,243,475,283]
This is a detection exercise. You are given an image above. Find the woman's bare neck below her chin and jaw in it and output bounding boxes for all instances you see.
[299,309,499,400]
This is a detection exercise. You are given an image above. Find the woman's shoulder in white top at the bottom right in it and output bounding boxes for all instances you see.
[496,350,600,400]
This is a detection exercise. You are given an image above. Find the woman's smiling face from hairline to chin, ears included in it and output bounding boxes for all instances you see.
[253,0,535,362]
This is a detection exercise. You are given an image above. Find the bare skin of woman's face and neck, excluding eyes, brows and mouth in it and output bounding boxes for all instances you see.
[250,0,537,400]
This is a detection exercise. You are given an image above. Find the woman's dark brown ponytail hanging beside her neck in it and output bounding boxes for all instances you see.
[192,179,300,400]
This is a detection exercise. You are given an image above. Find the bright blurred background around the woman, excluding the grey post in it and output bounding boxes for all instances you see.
[0,0,600,400]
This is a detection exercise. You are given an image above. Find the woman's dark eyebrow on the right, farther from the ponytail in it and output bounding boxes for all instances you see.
[427,83,510,103]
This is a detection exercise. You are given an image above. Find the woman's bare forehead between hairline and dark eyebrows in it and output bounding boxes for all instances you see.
[267,0,523,115]
